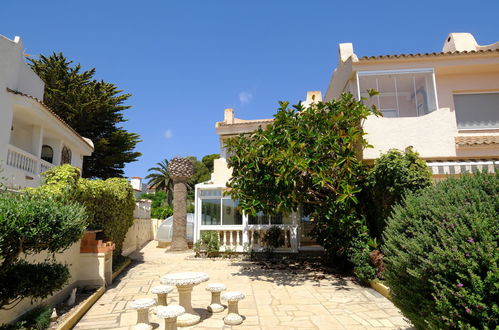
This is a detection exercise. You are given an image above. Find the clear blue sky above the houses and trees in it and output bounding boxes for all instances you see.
[0,0,499,176]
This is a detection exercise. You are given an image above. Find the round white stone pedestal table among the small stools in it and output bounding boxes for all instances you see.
[160,272,210,327]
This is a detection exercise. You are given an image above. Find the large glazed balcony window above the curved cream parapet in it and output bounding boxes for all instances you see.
[357,69,437,117]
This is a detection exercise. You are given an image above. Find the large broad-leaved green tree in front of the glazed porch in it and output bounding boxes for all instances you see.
[226,92,378,260]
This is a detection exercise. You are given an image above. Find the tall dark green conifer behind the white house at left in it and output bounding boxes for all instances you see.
[30,53,141,179]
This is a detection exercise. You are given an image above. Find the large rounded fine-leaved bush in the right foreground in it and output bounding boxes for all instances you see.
[384,173,499,329]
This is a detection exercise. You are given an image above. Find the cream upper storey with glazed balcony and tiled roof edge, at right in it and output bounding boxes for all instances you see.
[325,33,499,179]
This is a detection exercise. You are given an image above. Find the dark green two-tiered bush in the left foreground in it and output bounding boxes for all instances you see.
[0,193,86,309]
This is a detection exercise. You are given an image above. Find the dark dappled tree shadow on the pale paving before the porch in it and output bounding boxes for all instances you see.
[232,257,353,291]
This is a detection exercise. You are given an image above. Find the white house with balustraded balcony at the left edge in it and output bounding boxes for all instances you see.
[0,35,94,189]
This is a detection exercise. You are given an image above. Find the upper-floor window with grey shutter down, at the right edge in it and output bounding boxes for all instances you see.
[454,93,499,129]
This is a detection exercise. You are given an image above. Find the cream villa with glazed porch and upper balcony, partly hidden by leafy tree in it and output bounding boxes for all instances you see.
[194,33,499,252]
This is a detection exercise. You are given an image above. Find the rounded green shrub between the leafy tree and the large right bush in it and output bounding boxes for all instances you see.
[362,148,432,240]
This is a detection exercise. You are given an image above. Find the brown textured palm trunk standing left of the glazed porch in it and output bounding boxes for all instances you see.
[171,179,189,251]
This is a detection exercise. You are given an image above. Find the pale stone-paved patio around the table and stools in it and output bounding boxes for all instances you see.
[75,241,409,330]
